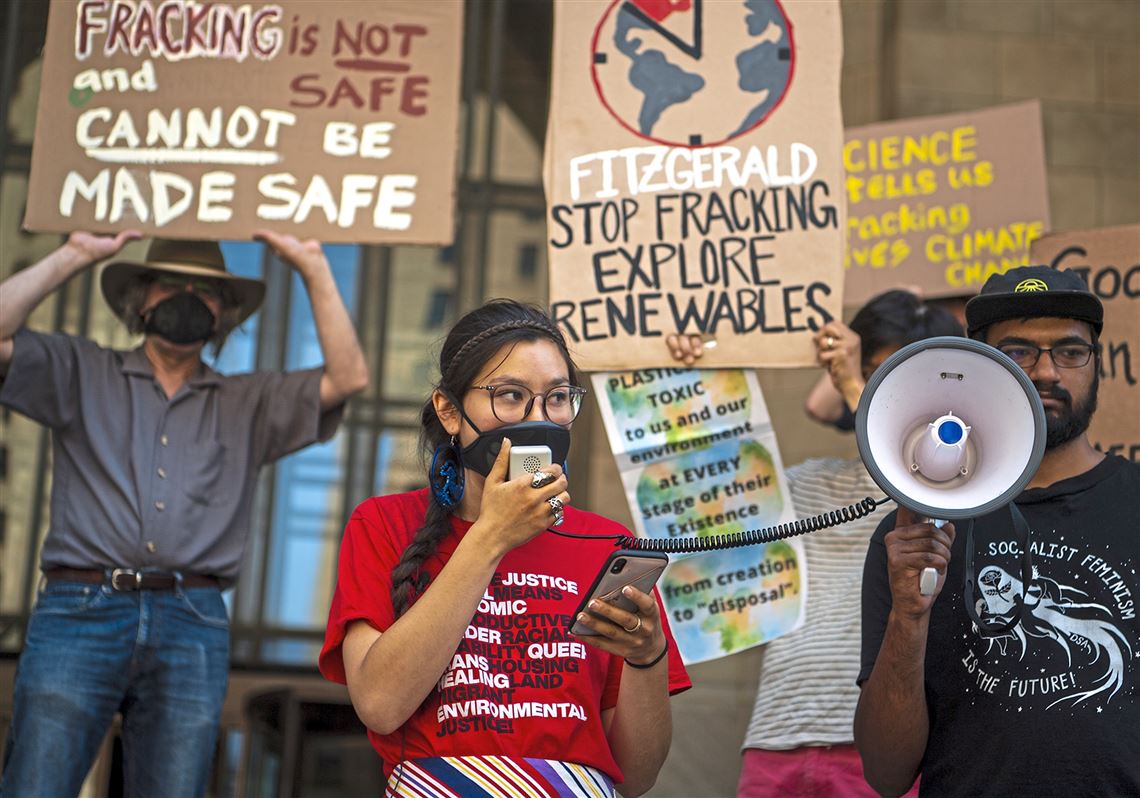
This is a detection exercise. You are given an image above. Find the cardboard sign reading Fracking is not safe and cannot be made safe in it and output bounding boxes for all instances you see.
[25,0,463,243]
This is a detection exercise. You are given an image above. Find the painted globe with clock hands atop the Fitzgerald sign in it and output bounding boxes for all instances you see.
[591,0,796,147]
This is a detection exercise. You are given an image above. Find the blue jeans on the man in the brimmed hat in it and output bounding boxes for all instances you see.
[0,581,229,798]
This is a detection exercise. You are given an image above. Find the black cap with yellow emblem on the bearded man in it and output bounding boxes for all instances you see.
[966,266,1105,337]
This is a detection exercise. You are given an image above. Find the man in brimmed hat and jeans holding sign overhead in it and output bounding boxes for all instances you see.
[0,231,368,798]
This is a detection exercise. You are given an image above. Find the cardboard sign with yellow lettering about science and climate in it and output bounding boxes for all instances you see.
[844,100,1049,306]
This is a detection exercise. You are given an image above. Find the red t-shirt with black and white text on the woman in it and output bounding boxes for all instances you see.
[320,489,691,782]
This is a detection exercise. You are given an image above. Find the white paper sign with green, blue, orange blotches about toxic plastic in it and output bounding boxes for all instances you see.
[593,368,807,662]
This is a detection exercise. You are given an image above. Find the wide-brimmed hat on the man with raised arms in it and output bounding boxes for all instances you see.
[99,238,266,324]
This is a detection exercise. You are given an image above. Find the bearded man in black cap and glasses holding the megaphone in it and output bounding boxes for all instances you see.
[855,267,1140,797]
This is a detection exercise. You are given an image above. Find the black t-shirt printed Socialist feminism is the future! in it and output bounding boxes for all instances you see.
[858,456,1140,797]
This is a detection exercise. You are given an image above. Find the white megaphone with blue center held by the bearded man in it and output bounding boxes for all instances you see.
[855,336,1045,622]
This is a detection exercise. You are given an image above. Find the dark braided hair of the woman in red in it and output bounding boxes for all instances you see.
[391,300,578,618]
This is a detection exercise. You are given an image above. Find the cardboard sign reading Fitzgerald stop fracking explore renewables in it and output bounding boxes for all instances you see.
[544,0,845,369]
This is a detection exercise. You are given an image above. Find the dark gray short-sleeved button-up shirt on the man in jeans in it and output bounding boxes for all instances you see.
[0,329,343,583]
